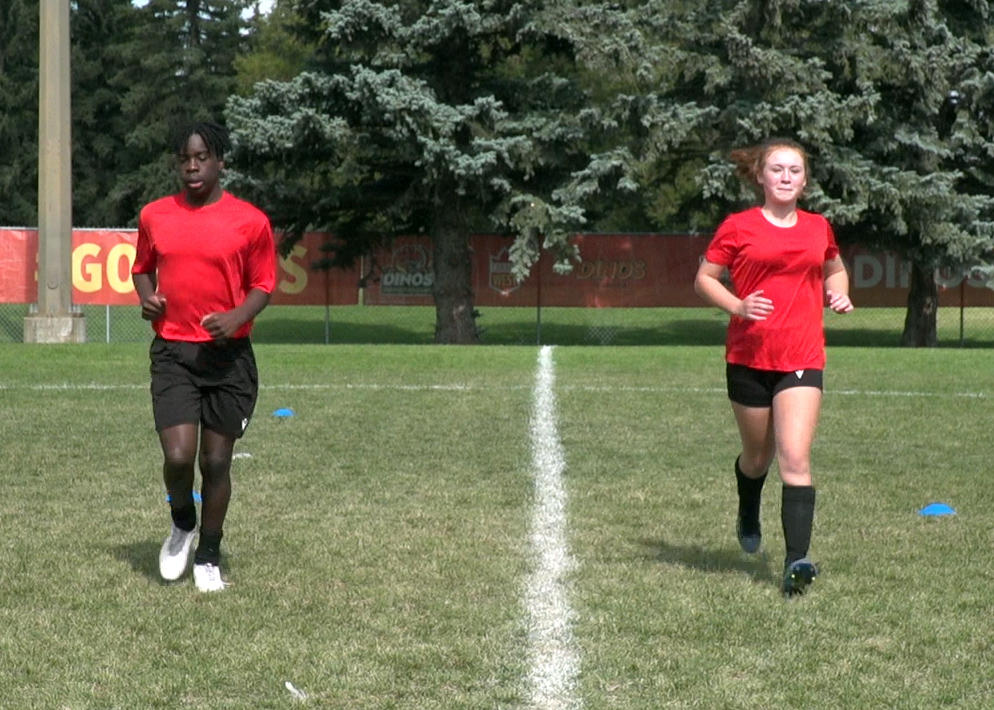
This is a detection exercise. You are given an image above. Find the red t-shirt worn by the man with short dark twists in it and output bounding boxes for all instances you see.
[131,192,276,342]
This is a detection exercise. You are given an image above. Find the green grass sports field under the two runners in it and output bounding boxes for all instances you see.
[0,330,994,710]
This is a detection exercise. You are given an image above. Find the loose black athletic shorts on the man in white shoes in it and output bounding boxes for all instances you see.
[149,337,259,439]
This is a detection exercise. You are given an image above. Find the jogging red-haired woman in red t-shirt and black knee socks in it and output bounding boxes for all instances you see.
[694,138,853,597]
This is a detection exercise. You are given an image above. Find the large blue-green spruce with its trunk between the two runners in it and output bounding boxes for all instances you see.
[227,0,626,343]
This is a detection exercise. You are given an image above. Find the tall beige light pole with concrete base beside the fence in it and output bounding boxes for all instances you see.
[24,0,86,343]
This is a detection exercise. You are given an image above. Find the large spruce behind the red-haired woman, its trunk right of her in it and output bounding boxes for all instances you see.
[590,0,994,345]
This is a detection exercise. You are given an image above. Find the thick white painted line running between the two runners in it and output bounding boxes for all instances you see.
[525,346,581,710]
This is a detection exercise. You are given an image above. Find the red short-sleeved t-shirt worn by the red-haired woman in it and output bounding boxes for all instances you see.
[704,207,839,372]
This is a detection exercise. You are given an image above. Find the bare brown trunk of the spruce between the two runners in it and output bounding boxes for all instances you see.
[432,204,480,345]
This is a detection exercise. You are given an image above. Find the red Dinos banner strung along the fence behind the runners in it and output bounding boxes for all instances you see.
[0,229,994,308]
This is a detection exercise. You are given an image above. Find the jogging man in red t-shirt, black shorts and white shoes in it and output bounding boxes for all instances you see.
[132,123,276,592]
